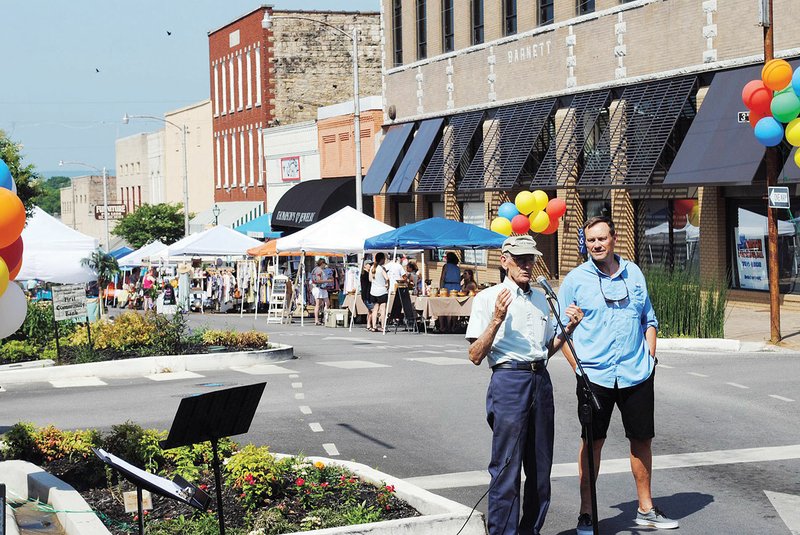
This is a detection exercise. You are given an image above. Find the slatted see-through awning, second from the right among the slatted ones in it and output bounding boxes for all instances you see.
[530,89,611,189]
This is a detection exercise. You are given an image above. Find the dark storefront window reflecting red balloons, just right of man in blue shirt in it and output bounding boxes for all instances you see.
[636,199,700,272]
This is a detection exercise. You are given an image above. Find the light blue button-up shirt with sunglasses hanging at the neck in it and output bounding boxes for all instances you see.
[558,256,658,388]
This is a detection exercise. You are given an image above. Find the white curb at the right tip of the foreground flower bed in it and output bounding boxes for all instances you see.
[274,453,487,535]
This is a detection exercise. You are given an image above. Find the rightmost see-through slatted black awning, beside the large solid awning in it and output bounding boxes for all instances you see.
[578,76,696,187]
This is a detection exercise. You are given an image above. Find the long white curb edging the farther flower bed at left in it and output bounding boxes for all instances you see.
[0,343,295,384]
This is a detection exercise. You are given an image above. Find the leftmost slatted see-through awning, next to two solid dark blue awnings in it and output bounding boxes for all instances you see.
[417,111,483,193]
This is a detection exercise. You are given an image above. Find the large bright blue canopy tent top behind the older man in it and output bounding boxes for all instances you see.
[364,217,506,250]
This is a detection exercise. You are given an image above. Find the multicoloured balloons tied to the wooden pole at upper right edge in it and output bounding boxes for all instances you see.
[742,59,800,166]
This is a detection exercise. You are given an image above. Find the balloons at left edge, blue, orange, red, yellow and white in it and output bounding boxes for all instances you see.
[0,160,28,339]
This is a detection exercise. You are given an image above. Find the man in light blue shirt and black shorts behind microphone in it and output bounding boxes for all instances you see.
[558,217,678,535]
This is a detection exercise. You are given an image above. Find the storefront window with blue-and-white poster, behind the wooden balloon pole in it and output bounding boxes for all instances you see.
[730,203,800,294]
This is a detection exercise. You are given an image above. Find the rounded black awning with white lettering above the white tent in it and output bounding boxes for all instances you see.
[272,177,372,231]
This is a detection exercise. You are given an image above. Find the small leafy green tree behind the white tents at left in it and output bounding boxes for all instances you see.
[112,203,183,249]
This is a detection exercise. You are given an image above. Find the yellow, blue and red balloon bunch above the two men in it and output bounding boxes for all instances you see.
[490,189,567,236]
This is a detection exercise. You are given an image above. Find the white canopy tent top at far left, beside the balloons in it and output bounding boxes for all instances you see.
[17,206,99,284]
